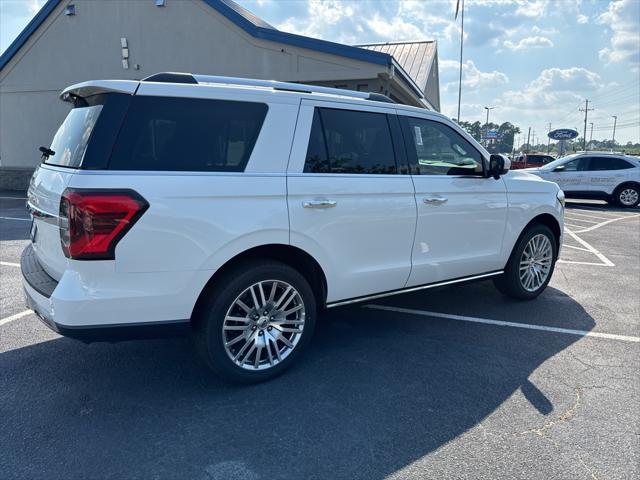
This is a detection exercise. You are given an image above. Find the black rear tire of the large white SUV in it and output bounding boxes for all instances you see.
[193,260,316,384]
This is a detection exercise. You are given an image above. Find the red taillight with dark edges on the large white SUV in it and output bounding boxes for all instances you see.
[59,188,149,260]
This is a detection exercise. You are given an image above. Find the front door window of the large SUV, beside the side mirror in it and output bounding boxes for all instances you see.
[403,117,484,175]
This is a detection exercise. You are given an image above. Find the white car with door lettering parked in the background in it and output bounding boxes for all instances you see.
[525,152,640,208]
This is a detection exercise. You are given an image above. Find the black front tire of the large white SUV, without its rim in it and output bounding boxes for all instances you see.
[493,223,558,300]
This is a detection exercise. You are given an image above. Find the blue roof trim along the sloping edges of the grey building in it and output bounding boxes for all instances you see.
[0,0,424,98]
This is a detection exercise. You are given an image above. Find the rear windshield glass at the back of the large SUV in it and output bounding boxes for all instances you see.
[44,105,102,168]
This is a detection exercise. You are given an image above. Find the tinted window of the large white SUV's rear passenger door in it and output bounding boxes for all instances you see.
[304,108,398,174]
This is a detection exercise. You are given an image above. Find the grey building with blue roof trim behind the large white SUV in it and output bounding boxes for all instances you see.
[0,0,440,189]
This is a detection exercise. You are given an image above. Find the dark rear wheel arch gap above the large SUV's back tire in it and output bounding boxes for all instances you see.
[191,243,327,319]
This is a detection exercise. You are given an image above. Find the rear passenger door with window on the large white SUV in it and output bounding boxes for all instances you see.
[287,100,416,302]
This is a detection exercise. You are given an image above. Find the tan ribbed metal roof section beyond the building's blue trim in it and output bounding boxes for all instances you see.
[358,41,436,91]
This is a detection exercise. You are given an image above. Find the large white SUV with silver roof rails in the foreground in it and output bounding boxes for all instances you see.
[21,73,564,382]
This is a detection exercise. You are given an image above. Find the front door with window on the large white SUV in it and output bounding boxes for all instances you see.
[400,113,508,286]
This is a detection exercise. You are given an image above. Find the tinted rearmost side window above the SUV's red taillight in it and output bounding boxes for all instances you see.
[109,96,267,172]
